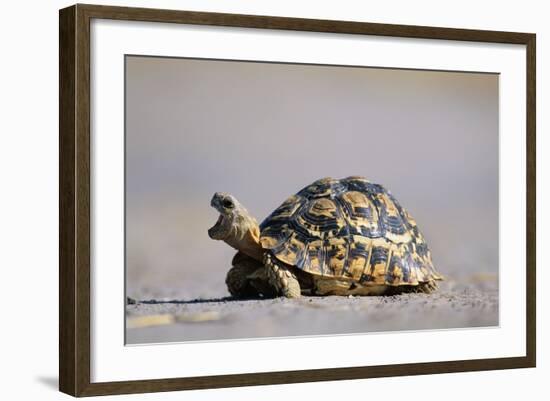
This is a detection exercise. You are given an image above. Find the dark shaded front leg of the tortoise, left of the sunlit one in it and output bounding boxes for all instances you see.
[225,252,277,298]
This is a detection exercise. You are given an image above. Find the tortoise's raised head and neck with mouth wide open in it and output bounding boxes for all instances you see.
[208,192,263,261]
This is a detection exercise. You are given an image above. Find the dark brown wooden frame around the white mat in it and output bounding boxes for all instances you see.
[59,4,536,396]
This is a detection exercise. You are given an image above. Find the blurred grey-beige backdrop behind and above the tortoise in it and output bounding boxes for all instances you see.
[126,56,498,340]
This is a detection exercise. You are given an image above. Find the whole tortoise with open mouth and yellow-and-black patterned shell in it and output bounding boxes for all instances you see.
[208,176,442,298]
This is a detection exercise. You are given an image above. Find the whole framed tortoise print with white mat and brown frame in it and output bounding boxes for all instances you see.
[59,5,536,396]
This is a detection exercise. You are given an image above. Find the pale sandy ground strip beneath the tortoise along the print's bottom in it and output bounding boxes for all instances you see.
[126,274,498,344]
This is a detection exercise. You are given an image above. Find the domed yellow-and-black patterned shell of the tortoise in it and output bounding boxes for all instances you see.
[260,177,441,286]
